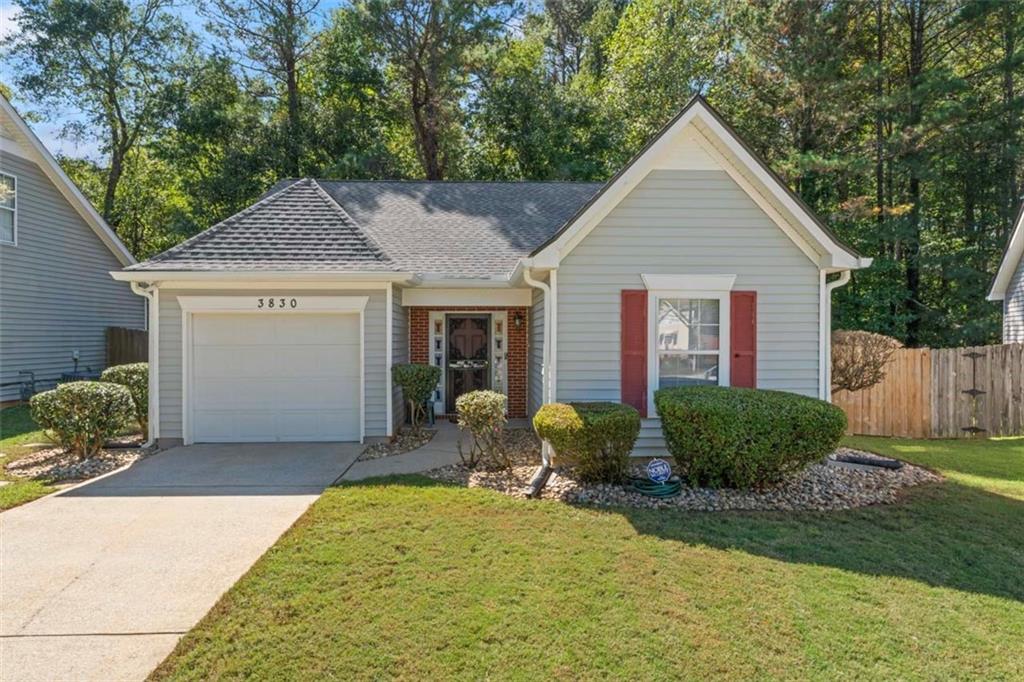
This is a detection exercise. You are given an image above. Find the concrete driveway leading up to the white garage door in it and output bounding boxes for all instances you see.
[0,443,361,682]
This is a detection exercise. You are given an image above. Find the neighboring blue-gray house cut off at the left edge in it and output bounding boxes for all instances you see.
[0,95,145,402]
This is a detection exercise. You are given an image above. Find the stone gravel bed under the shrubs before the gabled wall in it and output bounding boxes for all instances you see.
[426,436,942,511]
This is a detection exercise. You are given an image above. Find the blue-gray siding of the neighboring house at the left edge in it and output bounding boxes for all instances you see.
[0,154,145,400]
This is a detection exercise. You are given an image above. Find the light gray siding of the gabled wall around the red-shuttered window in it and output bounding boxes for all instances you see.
[557,170,819,408]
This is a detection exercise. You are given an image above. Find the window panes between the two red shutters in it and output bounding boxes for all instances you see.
[655,298,722,388]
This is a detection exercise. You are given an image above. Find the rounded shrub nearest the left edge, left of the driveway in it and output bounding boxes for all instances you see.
[29,381,135,458]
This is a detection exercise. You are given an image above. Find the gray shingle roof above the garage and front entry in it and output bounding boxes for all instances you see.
[130,178,602,278]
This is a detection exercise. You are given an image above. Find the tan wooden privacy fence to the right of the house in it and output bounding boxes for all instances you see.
[833,343,1024,438]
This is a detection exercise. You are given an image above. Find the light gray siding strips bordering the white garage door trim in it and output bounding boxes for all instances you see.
[159,289,389,439]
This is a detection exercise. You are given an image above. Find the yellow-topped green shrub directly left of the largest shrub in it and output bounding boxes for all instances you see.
[534,402,640,483]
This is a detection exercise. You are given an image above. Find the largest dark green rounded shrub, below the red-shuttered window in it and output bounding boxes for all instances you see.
[654,386,846,488]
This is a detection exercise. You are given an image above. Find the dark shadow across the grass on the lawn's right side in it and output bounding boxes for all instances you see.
[608,481,1024,601]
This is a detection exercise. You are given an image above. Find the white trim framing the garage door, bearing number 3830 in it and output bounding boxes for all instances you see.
[178,290,370,445]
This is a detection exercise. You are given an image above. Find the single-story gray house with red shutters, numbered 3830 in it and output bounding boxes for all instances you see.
[113,98,870,454]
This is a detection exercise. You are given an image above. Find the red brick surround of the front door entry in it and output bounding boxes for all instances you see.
[409,306,529,419]
